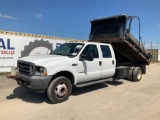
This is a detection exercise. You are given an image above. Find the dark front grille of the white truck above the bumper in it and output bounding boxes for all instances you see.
[17,60,34,75]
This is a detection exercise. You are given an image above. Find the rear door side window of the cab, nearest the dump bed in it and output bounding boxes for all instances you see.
[101,45,112,58]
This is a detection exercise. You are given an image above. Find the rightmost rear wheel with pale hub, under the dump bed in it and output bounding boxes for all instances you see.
[132,67,142,82]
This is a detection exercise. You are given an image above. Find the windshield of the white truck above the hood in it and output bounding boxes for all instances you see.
[50,43,84,56]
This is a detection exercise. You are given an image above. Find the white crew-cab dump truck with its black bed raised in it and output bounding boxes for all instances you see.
[17,15,151,103]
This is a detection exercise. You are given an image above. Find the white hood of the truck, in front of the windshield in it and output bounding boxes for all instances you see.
[19,54,70,66]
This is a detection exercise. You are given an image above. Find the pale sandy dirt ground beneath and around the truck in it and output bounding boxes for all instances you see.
[0,63,160,120]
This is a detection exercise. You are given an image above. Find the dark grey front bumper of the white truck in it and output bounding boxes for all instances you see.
[16,74,52,90]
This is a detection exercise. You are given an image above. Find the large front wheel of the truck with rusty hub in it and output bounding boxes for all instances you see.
[47,77,72,103]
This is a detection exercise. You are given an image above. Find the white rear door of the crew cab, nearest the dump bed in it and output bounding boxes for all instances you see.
[100,45,116,78]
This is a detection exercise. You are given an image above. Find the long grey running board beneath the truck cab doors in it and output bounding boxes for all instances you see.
[75,78,113,87]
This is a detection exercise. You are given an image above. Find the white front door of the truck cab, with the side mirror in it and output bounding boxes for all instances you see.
[78,45,101,83]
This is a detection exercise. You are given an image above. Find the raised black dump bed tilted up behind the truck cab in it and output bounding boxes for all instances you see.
[89,15,151,65]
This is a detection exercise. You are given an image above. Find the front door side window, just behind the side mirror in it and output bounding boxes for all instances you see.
[82,45,99,58]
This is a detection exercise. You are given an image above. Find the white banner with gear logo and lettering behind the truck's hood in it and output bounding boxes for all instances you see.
[0,35,66,72]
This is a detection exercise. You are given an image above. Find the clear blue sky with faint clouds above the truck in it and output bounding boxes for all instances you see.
[0,0,160,49]
